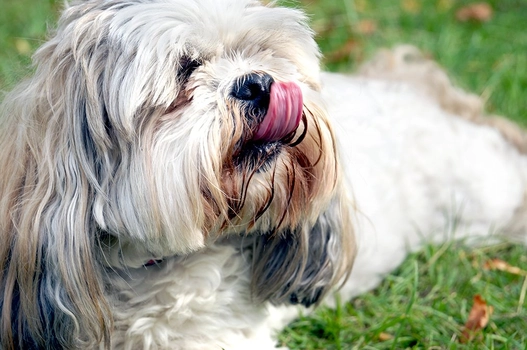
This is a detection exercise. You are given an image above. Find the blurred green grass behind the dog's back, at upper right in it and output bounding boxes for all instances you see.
[302,0,527,125]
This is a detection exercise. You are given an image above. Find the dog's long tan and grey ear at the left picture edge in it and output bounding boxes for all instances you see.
[0,39,111,350]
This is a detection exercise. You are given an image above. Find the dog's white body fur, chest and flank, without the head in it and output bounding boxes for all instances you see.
[100,74,527,349]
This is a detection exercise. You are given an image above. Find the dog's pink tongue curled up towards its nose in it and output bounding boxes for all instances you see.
[253,82,303,142]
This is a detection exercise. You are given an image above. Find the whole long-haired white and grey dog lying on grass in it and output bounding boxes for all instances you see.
[0,0,527,350]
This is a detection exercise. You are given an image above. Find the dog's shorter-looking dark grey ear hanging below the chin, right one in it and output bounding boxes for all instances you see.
[252,192,355,307]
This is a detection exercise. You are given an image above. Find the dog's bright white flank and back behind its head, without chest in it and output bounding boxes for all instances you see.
[324,74,527,296]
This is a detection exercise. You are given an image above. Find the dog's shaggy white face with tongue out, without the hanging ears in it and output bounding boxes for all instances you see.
[72,1,337,263]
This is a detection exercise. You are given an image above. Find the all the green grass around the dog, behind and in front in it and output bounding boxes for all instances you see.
[0,0,527,349]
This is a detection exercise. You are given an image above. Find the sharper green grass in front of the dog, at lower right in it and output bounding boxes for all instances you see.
[280,243,527,349]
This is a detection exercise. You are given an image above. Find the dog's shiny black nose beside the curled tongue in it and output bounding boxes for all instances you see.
[231,73,274,109]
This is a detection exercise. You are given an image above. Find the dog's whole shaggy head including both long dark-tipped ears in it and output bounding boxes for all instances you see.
[0,0,353,349]
